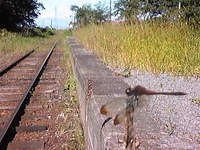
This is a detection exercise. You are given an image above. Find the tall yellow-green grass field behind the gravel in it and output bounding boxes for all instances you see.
[73,22,200,76]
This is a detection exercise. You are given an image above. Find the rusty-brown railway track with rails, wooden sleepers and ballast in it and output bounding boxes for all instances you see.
[0,42,63,150]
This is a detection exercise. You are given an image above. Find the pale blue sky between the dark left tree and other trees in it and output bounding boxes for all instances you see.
[35,0,110,29]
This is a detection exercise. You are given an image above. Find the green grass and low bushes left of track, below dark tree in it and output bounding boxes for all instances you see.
[0,28,55,55]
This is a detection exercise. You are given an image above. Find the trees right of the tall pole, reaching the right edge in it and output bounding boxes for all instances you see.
[115,0,200,27]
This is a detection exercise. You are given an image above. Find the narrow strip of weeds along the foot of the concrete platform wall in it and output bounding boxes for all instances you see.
[58,31,84,150]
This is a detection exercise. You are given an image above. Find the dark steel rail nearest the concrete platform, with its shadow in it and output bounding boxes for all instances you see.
[0,40,58,149]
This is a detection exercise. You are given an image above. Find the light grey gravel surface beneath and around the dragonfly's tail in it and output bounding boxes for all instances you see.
[111,68,200,149]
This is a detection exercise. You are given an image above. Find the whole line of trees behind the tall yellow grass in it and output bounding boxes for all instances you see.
[71,0,200,26]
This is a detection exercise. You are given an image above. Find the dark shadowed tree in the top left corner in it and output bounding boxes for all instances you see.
[0,0,44,31]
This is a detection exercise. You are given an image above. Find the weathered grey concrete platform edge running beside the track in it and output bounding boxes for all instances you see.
[68,35,128,150]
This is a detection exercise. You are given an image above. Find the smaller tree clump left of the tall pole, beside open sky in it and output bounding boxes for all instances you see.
[70,2,109,26]
